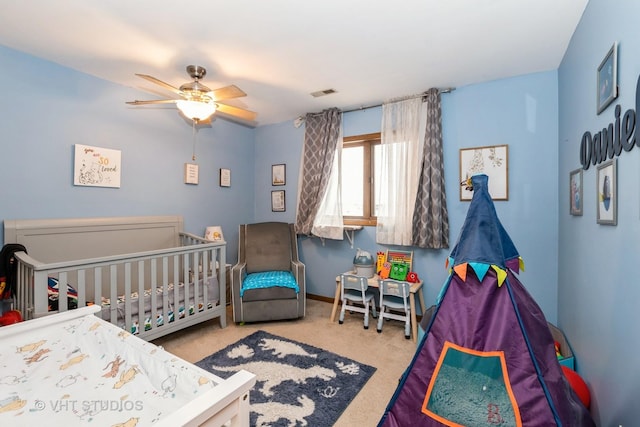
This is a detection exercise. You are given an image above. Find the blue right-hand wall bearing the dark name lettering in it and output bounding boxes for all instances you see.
[558,0,640,426]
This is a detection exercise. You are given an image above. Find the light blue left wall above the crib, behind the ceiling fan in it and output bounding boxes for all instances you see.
[0,47,255,259]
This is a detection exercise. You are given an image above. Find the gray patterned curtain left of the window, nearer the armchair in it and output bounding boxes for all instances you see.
[295,108,342,235]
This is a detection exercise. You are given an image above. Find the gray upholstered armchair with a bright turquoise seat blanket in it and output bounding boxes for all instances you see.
[231,222,306,323]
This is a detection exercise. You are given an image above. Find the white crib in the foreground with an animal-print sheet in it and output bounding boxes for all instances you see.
[0,305,256,427]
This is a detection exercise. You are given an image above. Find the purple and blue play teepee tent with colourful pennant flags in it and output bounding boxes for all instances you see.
[379,175,595,427]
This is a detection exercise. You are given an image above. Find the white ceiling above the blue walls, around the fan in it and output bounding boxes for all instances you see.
[0,0,588,125]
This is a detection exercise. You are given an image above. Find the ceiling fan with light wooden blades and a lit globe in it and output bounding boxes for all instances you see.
[127,65,257,123]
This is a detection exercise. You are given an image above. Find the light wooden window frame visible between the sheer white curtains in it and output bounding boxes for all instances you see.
[341,132,382,226]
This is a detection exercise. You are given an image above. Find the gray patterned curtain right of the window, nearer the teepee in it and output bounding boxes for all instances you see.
[412,88,449,249]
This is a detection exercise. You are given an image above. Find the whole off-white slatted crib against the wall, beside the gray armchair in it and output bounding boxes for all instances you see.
[4,216,226,340]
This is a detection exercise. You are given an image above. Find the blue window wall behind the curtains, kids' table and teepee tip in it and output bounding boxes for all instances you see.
[256,71,558,322]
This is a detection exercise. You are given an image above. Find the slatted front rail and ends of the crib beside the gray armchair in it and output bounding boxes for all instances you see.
[15,232,226,340]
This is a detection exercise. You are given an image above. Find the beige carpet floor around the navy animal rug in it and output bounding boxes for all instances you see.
[154,299,416,427]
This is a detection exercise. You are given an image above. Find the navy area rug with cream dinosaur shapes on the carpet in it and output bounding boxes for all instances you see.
[196,331,376,427]
